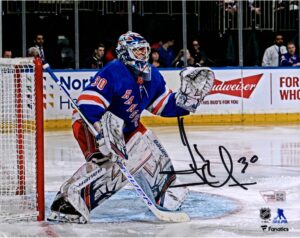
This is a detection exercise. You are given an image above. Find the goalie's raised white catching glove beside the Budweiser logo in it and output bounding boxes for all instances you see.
[176,67,215,112]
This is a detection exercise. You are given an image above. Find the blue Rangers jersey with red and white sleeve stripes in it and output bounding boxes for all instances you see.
[77,60,189,133]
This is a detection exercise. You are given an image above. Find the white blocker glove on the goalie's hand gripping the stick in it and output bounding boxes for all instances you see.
[94,112,127,162]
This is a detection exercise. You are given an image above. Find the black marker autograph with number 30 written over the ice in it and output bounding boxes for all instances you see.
[161,117,258,190]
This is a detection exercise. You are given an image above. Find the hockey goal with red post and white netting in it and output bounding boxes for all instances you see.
[0,58,44,222]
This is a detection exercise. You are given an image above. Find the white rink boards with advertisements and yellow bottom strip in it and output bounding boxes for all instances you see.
[44,68,300,130]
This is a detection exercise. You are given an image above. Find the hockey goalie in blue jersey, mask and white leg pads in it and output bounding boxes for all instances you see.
[48,31,214,223]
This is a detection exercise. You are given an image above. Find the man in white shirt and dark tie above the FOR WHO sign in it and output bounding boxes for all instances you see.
[262,34,287,66]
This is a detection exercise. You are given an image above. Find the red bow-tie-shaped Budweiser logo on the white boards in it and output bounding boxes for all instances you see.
[210,74,263,98]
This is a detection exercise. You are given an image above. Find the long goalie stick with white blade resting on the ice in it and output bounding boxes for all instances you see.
[43,63,190,222]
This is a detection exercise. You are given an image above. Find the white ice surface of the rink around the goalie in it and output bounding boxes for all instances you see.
[0,126,300,237]
